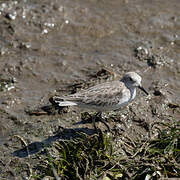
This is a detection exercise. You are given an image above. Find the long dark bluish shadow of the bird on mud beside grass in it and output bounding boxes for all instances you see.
[12,127,96,158]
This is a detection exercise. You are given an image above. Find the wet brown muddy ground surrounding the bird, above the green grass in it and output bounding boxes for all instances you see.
[0,0,180,179]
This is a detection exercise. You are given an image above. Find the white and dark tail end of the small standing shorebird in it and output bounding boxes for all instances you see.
[49,96,77,106]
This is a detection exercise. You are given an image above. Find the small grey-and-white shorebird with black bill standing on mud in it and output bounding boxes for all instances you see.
[51,72,148,130]
